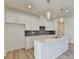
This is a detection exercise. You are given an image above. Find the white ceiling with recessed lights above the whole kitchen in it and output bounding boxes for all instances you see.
[5,0,74,18]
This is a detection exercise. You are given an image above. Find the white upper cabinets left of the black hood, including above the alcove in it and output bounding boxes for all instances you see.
[5,10,39,30]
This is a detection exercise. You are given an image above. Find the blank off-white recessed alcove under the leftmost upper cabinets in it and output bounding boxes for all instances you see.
[5,23,25,51]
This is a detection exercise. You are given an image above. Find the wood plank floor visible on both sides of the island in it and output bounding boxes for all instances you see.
[5,46,74,59]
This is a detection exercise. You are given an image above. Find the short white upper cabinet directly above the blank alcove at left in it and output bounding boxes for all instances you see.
[6,11,27,24]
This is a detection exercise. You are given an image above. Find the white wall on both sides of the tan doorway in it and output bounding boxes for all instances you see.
[49,17,74,43]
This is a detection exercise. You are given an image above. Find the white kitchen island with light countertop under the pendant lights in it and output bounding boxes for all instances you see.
[34,37,68,59]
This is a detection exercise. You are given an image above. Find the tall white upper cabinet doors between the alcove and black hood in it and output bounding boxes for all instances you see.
[25,16,39,30]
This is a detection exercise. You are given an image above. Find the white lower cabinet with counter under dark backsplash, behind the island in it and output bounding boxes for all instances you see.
[25,35,54,49]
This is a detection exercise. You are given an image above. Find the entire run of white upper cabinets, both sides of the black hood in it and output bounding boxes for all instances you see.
[5,10,54,30]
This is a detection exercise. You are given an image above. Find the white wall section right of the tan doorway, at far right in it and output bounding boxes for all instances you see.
[65,17,74,43]
